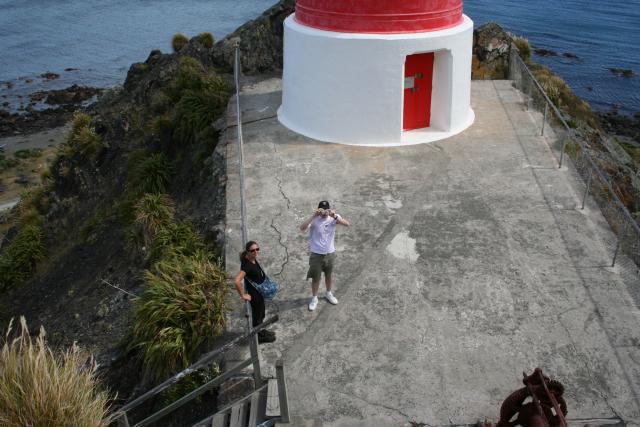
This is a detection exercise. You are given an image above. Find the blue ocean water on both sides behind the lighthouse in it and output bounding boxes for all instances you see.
[0,0,640,113]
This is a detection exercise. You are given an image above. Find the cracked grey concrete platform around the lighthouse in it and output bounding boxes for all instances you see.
[223,79,640,426]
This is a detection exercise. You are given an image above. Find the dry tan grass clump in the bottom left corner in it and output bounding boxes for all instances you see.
[0,317,114,427]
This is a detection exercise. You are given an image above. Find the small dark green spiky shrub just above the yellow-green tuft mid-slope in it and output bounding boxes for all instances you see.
[129,153,173,195]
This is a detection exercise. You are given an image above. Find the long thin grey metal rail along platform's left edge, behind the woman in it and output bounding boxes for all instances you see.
[233,41,262,388]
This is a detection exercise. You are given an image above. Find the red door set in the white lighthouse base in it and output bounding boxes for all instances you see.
[402,52,434,130]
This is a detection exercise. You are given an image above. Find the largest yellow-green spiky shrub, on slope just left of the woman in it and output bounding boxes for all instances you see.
[130,252,226,380]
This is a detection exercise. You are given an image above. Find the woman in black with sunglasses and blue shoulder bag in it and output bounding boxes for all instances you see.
[236,241,276,343]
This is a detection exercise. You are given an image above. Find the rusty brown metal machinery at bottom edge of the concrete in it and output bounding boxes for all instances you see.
[495,368,567,427]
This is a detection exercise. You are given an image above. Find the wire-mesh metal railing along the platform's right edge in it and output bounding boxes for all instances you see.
[509,46,640,267]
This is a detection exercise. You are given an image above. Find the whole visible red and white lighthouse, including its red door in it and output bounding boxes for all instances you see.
[278,0,474,146]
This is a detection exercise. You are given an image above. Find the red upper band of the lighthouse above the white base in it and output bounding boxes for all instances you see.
[296,0,462,33]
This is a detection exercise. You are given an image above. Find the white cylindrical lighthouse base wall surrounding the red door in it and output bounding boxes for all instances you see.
[278,16,474,146]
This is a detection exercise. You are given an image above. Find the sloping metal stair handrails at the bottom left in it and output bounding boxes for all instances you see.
[118,315,280,427]
